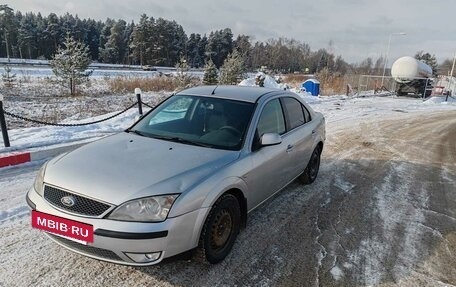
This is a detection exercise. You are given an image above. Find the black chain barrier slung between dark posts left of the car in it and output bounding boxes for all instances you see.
[0,95,154,147]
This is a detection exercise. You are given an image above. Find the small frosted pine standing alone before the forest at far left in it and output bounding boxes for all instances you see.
[50,34,92,95]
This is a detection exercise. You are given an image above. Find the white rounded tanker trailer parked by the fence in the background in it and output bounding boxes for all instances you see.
[391,56,432,96]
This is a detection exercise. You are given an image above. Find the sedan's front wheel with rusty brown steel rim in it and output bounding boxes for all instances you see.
[199,194,241,264]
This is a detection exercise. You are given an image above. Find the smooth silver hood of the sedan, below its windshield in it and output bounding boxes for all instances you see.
[44,132,239,205]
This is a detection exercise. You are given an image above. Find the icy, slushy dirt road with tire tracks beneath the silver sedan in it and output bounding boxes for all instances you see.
[0,111,456,286]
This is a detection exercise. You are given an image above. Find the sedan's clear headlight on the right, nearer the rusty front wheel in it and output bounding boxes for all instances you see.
[108,194,179,222]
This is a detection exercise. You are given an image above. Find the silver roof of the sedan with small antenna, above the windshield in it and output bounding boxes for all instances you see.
[176,85,285,103]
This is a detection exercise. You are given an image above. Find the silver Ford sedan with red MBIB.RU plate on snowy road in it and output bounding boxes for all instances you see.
[26,86,325,266]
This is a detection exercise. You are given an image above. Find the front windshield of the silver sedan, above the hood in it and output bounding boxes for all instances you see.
[129,95,254,150]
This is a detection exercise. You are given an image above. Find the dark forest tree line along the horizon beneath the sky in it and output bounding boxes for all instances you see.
[0,5,448,75]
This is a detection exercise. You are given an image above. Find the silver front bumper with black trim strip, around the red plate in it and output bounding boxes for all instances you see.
[26,187,208,266]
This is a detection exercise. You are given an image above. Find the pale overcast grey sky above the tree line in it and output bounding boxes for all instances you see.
[8,0,456,64]
